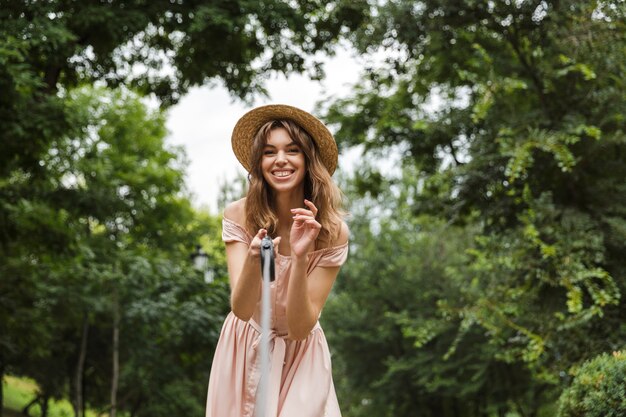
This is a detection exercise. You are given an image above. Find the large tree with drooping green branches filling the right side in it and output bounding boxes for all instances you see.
[325,0,626,415]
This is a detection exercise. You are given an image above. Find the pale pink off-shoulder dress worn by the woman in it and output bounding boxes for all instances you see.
[206,218,348,417]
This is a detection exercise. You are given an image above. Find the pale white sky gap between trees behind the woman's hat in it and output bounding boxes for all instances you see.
[167,48,362,214]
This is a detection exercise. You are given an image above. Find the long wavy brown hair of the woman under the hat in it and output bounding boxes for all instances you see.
[245,120,344,245]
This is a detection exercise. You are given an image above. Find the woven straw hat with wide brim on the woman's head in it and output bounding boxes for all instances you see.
[231,104,339,175]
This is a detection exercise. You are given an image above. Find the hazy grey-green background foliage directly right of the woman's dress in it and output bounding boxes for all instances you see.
[322,169,552,416]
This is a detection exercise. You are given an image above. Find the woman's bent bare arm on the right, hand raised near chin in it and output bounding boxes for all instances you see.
[287,200,348,340]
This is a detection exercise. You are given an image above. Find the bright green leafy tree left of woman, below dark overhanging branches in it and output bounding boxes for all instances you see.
[0,88,228,416]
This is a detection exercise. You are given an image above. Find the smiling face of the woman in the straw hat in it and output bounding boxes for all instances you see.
[261,127,306,192]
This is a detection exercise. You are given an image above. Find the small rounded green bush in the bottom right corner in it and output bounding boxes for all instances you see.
[559,351,626,417]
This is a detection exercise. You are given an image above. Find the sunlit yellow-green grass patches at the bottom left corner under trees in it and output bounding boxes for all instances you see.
[2,376,97,417]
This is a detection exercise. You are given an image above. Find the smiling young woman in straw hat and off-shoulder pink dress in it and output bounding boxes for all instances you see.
[206,105,348,417]
